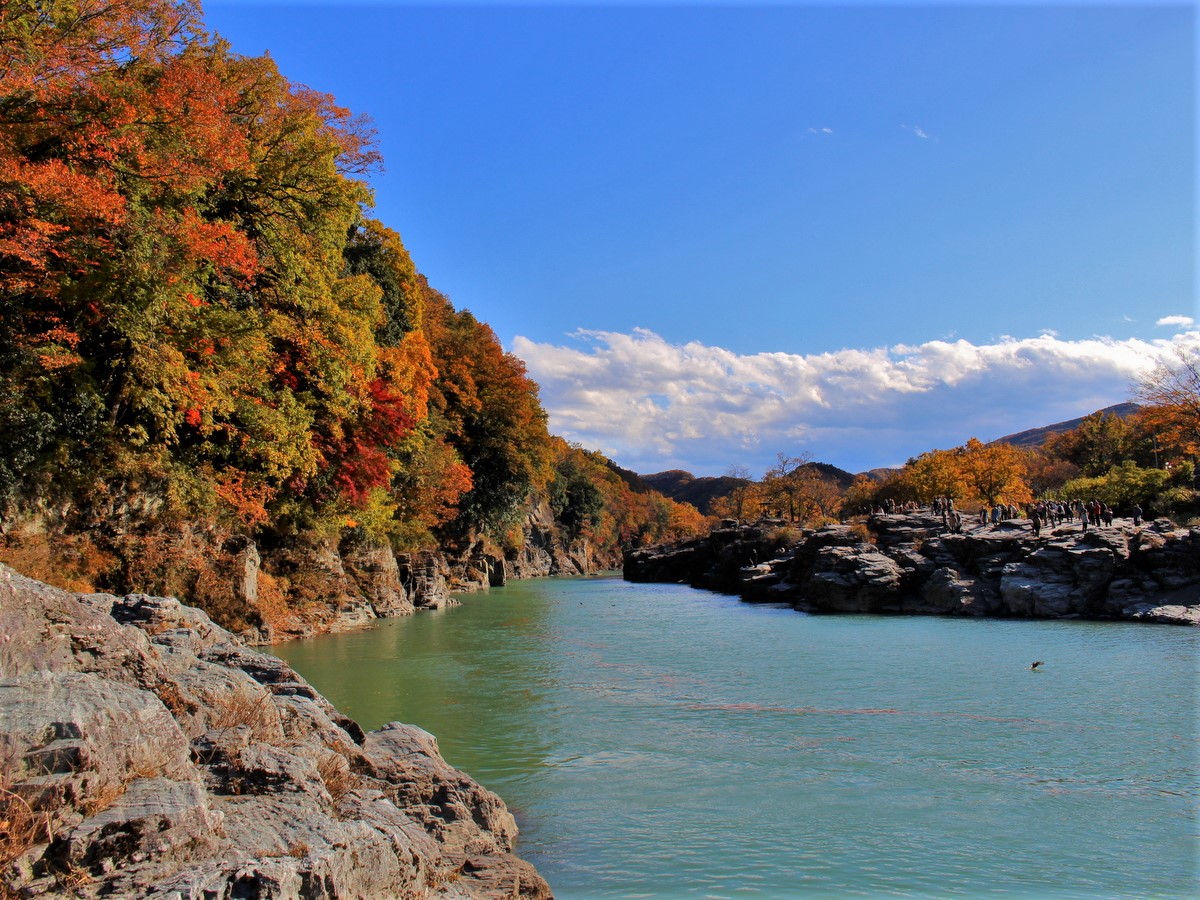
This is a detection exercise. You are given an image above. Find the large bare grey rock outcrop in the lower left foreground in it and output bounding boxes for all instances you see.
[0,566,551,900]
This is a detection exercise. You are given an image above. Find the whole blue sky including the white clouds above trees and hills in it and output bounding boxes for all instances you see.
[205,0,1200,474]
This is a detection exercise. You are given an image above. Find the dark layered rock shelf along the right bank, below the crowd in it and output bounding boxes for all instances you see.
[624,514,1200,625]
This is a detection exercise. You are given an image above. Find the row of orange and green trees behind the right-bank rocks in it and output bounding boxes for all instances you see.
[713,349,1200,523]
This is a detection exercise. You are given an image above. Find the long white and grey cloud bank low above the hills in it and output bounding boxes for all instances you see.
[512,329,1200,475]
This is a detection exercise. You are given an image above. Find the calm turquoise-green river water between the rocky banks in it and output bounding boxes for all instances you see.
[274,577,1200,900]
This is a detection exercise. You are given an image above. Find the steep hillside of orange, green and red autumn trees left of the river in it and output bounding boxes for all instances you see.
[0,0,700,638]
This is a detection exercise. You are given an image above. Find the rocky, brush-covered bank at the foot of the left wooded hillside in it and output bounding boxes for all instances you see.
[0,502,620,644]
